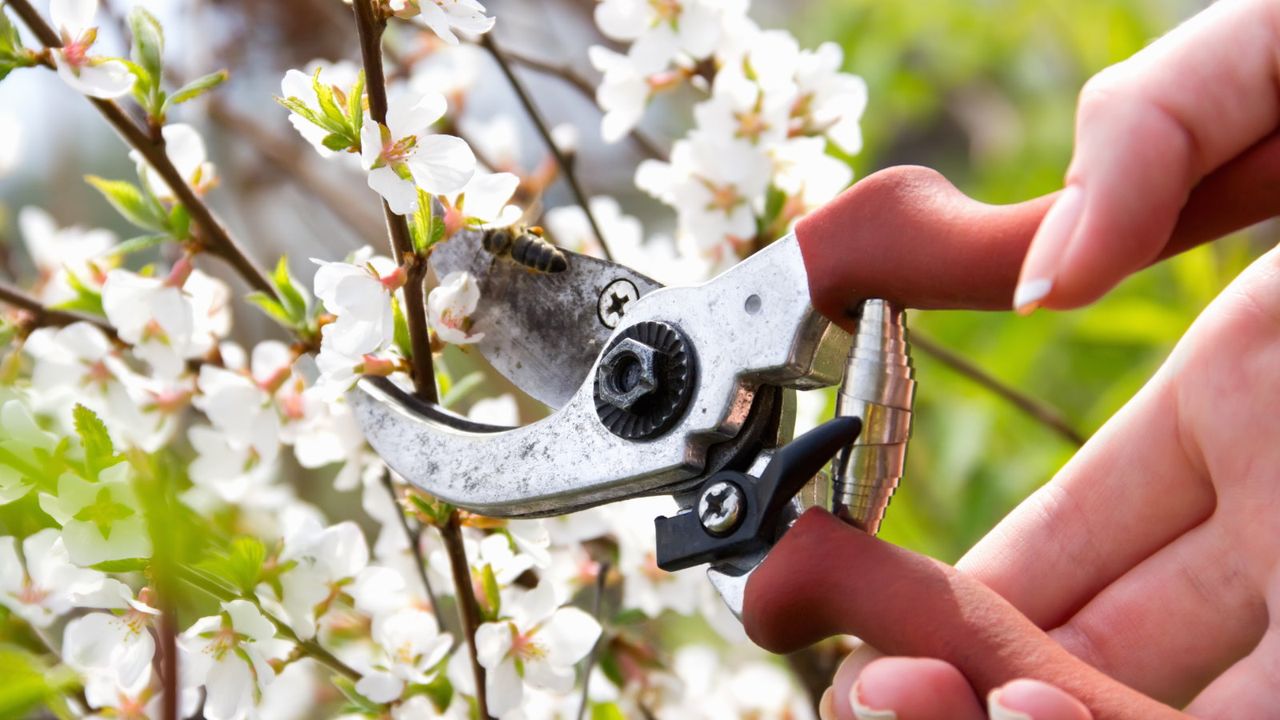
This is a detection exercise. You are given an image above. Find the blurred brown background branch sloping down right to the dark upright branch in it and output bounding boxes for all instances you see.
[209,100,379,237]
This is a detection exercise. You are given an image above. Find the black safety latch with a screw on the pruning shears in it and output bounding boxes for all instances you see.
[653,416,863,571]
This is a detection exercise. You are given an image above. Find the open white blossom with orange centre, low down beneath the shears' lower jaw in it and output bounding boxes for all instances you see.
[476,582,600,717]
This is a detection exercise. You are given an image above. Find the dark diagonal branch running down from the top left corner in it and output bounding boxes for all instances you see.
[8,0,275,296]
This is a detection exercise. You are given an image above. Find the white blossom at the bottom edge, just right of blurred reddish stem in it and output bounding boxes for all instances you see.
[178,600,275,720]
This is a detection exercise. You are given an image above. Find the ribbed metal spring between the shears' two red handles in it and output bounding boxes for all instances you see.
[832,300,915,534]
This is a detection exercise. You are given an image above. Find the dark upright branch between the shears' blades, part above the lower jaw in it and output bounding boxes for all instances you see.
[352,0,440,402]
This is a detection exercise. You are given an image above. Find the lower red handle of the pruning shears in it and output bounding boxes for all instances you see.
[742,509,1181,720]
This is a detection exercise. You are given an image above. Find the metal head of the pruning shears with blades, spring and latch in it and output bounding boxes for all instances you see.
[351,188,915,614]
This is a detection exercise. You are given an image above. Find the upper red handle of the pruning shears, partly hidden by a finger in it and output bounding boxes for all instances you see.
[796,135,1280,322]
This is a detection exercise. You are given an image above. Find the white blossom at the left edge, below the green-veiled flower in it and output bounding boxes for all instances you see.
[0,528,102,628]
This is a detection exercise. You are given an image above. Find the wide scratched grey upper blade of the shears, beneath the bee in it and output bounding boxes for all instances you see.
[431,231,662,409]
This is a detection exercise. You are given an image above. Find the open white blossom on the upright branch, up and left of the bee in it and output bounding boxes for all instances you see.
[360,92,476,215]
